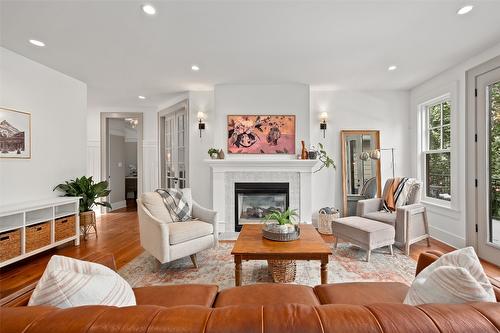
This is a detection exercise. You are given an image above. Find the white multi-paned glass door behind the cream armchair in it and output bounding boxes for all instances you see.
[159,103,189,188]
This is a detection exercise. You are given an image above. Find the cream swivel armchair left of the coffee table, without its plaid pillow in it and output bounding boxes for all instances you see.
[137,189,218,267]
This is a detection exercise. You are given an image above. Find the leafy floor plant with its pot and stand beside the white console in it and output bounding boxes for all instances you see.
[54,176,111,239]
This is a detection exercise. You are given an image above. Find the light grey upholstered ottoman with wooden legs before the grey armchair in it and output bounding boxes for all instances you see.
[332,216,395,261]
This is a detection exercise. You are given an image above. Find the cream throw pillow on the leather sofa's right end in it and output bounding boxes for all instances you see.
[404,247,496,305]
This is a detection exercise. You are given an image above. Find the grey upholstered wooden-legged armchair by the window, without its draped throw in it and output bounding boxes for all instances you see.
[356,178,430,255]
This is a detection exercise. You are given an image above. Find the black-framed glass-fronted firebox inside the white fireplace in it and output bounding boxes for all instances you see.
[234,183,290,232]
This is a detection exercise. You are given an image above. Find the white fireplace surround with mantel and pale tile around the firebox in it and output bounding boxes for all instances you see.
[206,159,318,238]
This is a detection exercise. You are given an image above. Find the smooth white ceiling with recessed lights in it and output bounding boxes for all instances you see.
[1,0,500,107]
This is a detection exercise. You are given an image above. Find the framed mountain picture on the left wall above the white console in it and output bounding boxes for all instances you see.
[0,107,31,158]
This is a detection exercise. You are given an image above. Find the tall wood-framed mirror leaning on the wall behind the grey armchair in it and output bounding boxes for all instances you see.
[340,130,381,216]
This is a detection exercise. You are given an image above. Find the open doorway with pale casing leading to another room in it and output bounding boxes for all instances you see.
[101,113,143,212]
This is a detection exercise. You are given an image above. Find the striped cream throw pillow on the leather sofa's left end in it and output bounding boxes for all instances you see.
[28,255,136,308]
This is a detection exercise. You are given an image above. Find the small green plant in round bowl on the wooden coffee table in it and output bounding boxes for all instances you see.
[262,209,300,241]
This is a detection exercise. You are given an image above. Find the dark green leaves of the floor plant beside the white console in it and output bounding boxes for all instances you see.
[53,176,111,213]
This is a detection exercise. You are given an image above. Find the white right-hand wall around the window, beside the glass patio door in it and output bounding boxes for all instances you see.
[410,44,500,247]
